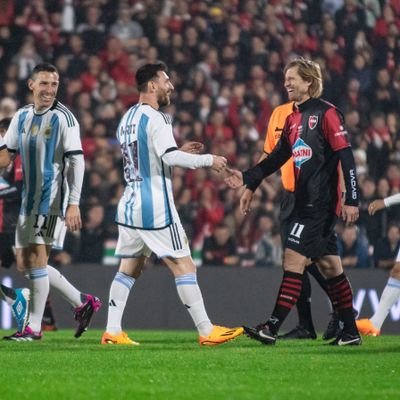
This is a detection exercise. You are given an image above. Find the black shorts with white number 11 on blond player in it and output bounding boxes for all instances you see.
[285,207,339,260]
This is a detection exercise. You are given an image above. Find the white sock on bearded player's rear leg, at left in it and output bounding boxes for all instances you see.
[106,272,135,335]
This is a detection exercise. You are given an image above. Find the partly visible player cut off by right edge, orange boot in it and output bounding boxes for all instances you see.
[356,193,400,336]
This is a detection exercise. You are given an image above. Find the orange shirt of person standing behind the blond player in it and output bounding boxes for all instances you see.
[264,102,295,192]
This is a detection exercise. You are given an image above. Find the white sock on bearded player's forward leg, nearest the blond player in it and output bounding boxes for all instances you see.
[175,272,213,336]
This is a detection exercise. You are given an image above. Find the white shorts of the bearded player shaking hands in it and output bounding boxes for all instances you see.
[115,222,190,258]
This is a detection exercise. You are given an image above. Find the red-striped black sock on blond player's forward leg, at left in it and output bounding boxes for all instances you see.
[268,271,303,335]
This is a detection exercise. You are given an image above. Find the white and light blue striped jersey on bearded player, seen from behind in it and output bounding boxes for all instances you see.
[116,103,179,229]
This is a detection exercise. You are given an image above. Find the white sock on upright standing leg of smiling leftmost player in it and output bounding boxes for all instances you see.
[29,267,50,332]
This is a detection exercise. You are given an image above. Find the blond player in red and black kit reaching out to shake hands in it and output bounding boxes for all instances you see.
[225,58,361,346]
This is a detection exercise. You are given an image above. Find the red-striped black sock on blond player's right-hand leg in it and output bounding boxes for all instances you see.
[326,273,358,333]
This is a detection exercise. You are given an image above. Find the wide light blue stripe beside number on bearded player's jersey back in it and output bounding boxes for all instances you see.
[137,114,154,229]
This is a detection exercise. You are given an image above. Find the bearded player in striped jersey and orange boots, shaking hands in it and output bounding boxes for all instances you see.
[101,63,243,346]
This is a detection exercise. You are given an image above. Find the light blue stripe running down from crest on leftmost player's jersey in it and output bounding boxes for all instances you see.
[39,114,60,215]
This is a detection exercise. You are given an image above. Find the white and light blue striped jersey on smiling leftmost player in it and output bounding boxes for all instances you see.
[5,101,83,215]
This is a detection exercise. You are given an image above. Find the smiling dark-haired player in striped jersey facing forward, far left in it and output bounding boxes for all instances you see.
[4,63,101,341]
